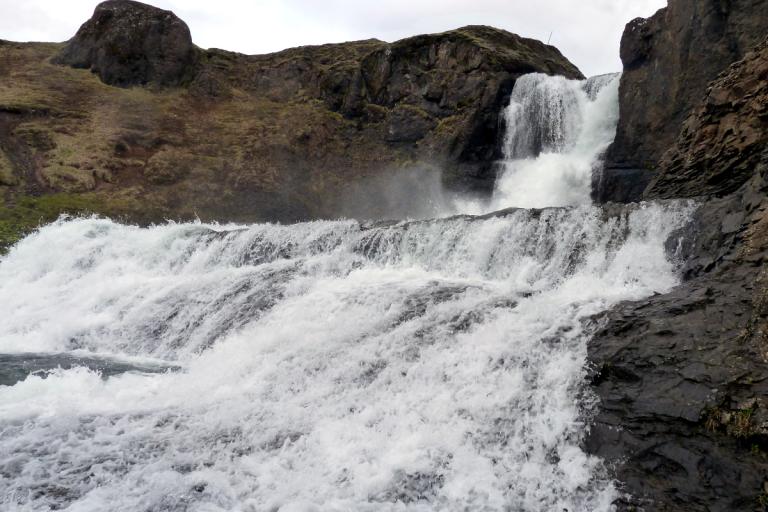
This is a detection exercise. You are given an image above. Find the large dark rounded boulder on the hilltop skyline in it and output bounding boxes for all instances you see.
[54,0,196,87]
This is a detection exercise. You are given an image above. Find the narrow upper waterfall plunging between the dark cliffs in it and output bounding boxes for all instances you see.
[490,73,620,211]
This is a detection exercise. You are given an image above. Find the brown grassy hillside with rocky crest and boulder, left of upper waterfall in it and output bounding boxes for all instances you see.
[0,0,582,250]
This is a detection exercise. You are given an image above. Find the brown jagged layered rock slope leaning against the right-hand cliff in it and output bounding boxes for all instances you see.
[646,40,768,198]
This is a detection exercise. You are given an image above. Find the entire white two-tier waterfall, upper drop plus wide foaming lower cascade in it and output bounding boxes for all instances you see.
[0,75,692,512]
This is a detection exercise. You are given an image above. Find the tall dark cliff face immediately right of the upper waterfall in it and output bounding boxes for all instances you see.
[598,0,768,201]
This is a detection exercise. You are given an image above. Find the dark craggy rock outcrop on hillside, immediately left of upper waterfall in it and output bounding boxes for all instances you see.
[356,26,584,191]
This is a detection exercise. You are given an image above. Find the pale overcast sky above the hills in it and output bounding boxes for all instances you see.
[0,0,666,75]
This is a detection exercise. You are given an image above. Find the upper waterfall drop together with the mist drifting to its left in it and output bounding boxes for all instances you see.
[338,73,621,219]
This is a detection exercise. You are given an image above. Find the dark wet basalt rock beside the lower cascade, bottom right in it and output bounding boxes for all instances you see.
[586,150,768,512]
